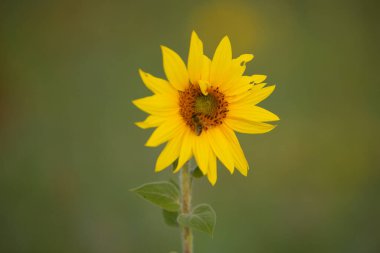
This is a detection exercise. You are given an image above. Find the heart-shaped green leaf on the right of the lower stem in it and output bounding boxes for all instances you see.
[178,204,216,237]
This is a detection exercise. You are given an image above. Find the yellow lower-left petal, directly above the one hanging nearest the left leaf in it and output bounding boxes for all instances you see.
[145,117,185,147]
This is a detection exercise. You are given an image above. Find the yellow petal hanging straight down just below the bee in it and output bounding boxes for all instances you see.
[193,133,210,175]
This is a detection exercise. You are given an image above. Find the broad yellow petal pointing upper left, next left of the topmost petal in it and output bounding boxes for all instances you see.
[161,46,189,91]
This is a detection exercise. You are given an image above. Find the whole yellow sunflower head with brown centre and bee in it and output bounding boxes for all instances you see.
[133,32,279,185]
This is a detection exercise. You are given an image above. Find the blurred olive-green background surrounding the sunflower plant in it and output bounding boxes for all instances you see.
[0,0,380,253]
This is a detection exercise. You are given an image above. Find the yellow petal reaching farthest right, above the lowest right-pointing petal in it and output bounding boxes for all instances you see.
[228,105,280,122]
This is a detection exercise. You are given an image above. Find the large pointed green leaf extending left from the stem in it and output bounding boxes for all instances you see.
[131,182,180,212]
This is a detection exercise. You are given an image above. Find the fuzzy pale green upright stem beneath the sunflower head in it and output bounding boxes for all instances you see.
[179,163,193,253]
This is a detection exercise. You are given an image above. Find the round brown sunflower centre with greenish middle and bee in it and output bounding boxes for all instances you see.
[179,84,228,135]
